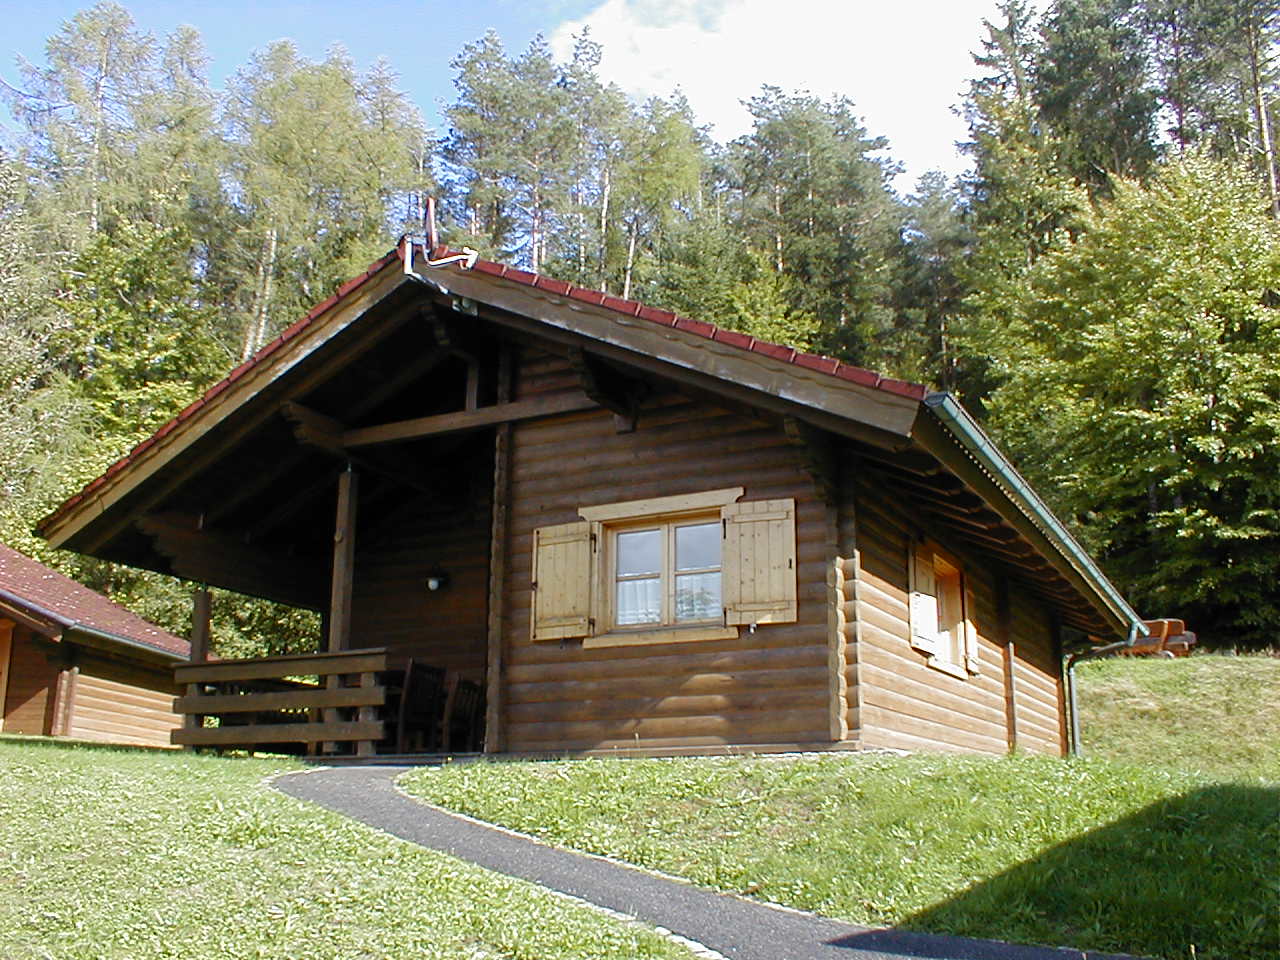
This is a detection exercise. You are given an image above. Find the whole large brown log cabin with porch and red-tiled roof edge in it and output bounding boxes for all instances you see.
[41,238,1144,756]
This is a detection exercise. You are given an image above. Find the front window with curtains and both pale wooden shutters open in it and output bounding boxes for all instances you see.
[532,486,796,646]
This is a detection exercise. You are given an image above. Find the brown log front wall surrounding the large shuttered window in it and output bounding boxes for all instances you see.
[502,349,831,751]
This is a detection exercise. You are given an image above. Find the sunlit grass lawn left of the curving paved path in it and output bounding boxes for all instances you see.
[0,740,691,960]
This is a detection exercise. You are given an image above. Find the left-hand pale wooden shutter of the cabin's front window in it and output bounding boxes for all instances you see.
[532,521,594,640]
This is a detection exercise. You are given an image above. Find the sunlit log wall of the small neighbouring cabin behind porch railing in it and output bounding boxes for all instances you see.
[65,652,182,748]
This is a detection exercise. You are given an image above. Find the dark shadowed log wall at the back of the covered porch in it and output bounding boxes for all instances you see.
[351,478,493,684]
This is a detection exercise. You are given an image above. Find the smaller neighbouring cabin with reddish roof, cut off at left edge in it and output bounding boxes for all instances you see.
[0,544,188,746]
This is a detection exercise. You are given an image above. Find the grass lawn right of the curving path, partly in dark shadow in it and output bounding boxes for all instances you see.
[404,658,1280,960]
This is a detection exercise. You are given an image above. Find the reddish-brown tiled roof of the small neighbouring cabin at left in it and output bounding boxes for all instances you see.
[0,544,191,657]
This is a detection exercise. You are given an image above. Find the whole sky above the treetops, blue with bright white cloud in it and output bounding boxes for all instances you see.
[0,0,1039,192]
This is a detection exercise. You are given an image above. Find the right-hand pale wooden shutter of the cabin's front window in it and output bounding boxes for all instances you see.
[721,499,796,626]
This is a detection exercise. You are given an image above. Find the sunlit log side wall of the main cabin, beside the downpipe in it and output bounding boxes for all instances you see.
[845,474,1062,754]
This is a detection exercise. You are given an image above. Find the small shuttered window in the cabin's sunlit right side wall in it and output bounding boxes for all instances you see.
[909,541,978,677]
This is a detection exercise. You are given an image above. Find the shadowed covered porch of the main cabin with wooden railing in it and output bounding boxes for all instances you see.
[36,262,555,756]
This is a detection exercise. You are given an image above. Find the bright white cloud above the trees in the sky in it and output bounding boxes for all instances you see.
[550,0,1018,191]
